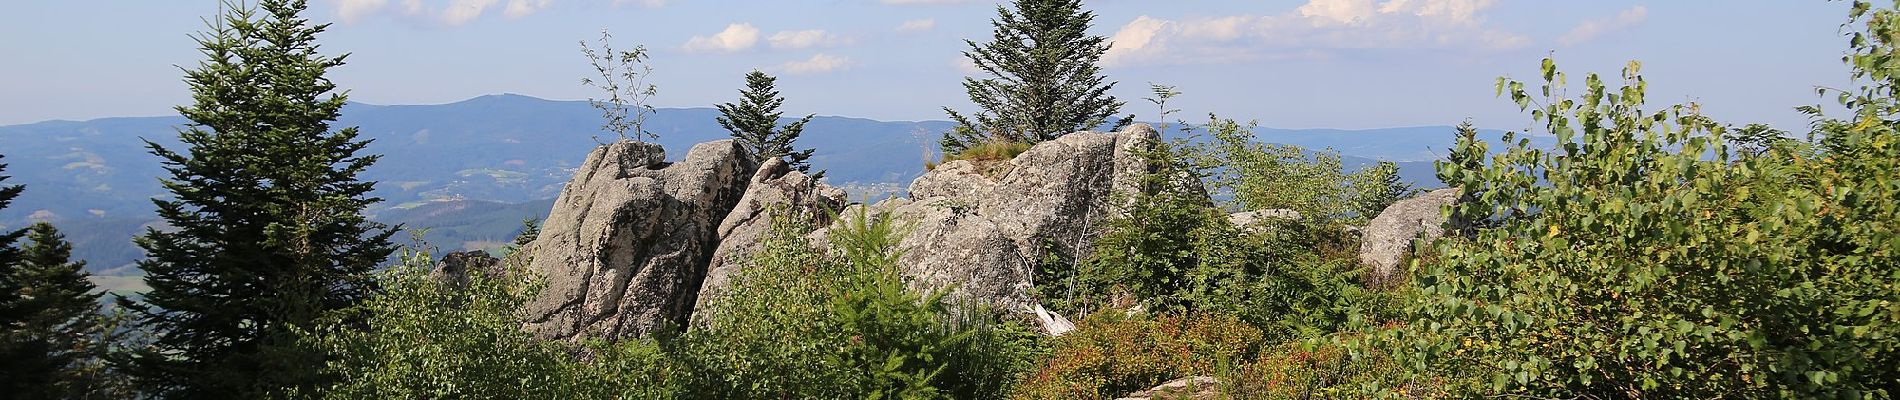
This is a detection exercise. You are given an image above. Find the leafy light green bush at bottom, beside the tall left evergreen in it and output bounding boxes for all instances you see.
[300,242,671,398]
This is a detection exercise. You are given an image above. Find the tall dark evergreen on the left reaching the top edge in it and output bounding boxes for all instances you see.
[122,0,393,398]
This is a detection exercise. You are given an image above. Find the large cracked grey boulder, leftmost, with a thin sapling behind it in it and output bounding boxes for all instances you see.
[509,140,758,339]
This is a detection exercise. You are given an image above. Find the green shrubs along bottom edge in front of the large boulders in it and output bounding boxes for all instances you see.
[293,207,1041,398]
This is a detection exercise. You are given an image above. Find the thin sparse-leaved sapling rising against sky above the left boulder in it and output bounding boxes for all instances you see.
[581,28,659,142]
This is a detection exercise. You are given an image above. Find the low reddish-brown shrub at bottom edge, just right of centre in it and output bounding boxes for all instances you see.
[1015,311,1260,400]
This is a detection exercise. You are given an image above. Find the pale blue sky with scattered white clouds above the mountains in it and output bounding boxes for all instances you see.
[0,0,1849,129]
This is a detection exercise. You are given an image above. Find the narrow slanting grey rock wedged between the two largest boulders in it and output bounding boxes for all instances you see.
[695,159,846,313]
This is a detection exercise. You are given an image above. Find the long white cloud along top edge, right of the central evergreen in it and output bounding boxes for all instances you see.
[1102,0,1530,64]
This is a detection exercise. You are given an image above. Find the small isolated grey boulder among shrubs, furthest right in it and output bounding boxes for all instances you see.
[1359,188,1459,286]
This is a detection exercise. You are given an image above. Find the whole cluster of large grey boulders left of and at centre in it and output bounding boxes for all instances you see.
[507,125,1185,339]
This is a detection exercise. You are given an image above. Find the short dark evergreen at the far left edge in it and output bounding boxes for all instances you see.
[0,222,103,398]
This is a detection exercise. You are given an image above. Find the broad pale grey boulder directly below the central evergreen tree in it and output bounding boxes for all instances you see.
[836,125,1185,311]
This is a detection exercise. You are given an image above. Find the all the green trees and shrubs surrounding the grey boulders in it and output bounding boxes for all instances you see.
[0,0,1900,398]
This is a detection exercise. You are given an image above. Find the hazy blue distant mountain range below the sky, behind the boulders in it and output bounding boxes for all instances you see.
[0,95,1542,273]
